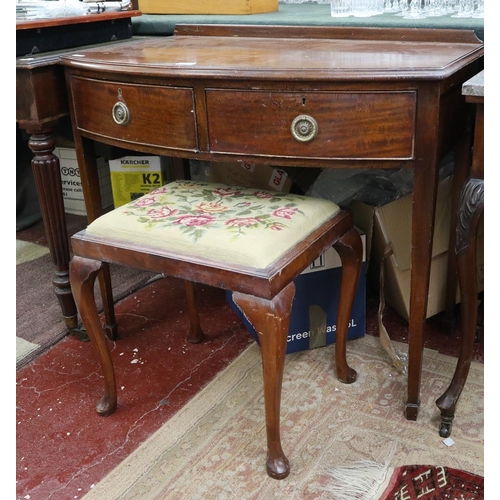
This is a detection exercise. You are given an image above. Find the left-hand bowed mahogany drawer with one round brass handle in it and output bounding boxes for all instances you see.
[70,77,198,150]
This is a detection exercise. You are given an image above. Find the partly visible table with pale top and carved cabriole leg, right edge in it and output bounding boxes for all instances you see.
[436,71,484,437]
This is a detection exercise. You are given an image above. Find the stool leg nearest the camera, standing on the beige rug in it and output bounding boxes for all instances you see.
[233,282,295,479]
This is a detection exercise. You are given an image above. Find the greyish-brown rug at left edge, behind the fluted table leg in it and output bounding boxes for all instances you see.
[16,240,154,369]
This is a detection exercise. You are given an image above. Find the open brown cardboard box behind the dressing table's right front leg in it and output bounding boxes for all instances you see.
[351,176,484,320]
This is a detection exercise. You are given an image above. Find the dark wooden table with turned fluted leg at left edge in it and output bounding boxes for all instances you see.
[16,11,141,331]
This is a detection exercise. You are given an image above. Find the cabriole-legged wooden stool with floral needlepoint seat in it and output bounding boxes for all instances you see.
[70,180,362,479]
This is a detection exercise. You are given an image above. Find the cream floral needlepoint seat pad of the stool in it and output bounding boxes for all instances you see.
[87,181,339,269]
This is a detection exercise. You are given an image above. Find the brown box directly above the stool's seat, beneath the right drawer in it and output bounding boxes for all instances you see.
[208,162,321,194]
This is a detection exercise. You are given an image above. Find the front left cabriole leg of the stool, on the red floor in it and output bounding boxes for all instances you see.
[70,256,117,416]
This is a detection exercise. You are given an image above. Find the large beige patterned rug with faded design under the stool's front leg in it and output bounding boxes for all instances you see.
[84,336,484,500]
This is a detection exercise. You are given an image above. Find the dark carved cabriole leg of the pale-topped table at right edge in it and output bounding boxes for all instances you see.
[436,179,484,437]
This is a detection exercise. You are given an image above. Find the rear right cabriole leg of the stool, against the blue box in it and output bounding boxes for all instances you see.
[333,228,363,384]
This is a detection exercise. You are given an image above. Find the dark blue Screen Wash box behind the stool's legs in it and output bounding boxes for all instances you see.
[226,234,366,354]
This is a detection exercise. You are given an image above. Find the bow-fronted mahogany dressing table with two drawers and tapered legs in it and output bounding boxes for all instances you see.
[60,25,483,420]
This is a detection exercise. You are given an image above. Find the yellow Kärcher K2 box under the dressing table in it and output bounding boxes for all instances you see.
[109,156,172,208]
